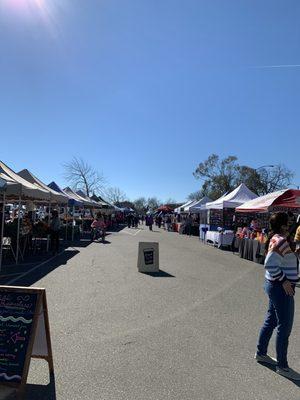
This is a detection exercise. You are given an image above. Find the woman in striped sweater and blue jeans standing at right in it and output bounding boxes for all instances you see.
[255,212,300,381]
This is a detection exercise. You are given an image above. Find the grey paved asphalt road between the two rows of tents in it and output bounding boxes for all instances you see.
[0,227,300,400]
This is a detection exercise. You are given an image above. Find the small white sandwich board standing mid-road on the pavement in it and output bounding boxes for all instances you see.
[138,242,159,272]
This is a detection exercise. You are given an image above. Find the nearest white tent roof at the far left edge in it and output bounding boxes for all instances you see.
[0,161,50,201]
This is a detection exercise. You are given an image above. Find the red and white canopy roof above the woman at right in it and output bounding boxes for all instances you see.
[235,189,300,213]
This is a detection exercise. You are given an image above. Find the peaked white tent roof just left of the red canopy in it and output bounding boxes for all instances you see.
[204,183,257,210]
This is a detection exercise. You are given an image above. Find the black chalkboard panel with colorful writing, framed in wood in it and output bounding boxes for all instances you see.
[0,287,39,384]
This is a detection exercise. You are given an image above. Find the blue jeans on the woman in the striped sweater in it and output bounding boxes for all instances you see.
[257,280,295,368]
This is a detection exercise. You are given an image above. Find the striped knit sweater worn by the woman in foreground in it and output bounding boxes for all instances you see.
[265,234,299,282]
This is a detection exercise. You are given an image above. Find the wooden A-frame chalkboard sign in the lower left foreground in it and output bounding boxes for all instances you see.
[0,286,54,397]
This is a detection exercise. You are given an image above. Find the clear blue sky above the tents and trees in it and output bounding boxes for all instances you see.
[0,0,300,201]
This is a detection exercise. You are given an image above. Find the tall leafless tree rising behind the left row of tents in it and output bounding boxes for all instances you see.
[63,157,105,196]
